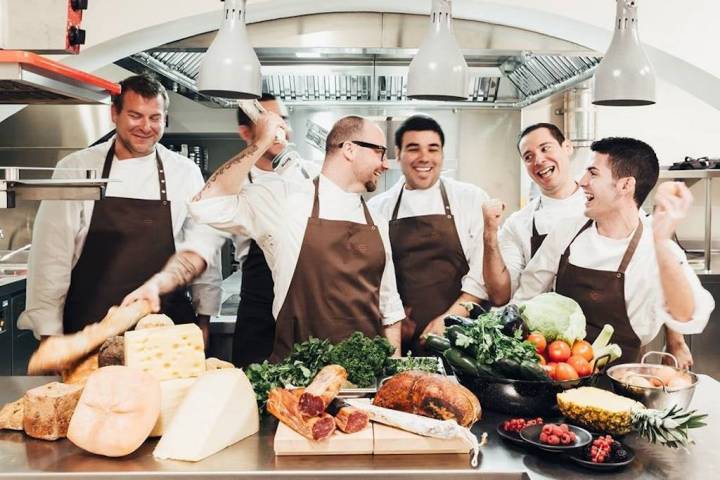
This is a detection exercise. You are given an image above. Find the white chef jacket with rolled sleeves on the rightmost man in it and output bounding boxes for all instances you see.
[512,213,715,345]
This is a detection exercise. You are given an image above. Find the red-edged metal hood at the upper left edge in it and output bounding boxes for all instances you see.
[0,50,120,105]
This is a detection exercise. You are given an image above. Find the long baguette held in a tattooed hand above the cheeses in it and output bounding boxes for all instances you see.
[28,300,151,375]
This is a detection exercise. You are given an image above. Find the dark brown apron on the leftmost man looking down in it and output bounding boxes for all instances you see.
[63,142,195,333]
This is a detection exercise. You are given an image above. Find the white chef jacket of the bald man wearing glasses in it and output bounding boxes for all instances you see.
[189,175,405,325]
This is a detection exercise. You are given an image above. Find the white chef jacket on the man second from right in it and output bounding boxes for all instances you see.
[463,187,585,299]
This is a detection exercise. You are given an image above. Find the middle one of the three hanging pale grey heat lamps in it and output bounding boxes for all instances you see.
[408,0,468,101]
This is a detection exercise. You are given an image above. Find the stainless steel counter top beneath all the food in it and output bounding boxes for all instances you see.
[0,375,720,480]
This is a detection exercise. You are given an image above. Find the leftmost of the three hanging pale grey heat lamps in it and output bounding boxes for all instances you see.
[197,0,262,99]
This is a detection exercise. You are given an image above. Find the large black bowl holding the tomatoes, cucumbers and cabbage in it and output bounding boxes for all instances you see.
[453,368,602,418]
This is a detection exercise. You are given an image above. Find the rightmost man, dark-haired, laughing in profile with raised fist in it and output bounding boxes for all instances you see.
[513,138,715,362]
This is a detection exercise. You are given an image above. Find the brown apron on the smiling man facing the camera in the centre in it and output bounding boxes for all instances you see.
[390,180,470,356]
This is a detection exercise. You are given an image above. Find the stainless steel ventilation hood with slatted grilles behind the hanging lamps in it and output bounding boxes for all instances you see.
[117,48,601,108]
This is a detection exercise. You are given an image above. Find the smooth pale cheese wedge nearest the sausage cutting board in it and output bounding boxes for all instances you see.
[153,368,260,462]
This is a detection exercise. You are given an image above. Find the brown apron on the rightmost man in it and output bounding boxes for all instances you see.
[555,220,643,364]
